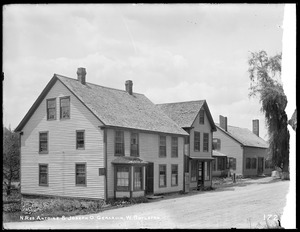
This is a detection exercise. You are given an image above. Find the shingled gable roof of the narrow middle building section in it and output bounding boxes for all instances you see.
[157,100,216,131]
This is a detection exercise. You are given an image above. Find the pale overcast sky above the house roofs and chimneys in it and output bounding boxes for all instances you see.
[3,4,284,139]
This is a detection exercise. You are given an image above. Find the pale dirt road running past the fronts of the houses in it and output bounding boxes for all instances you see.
[4,177,289,229]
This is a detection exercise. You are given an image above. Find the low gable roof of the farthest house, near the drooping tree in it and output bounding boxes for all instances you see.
[216,124,269,148]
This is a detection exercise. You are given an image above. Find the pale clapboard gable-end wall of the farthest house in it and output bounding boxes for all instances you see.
[213,128,243,175]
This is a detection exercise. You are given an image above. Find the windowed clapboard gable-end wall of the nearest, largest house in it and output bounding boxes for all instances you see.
[21,81,105,199]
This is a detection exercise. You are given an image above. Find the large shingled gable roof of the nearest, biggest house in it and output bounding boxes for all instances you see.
[16,74,187,135]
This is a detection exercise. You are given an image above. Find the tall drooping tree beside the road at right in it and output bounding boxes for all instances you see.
[248,51,290,178]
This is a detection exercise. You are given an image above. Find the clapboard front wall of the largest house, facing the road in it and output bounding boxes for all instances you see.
[107,129,184,198]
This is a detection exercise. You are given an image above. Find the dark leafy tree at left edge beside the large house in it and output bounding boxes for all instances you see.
[3,127,20,195]
